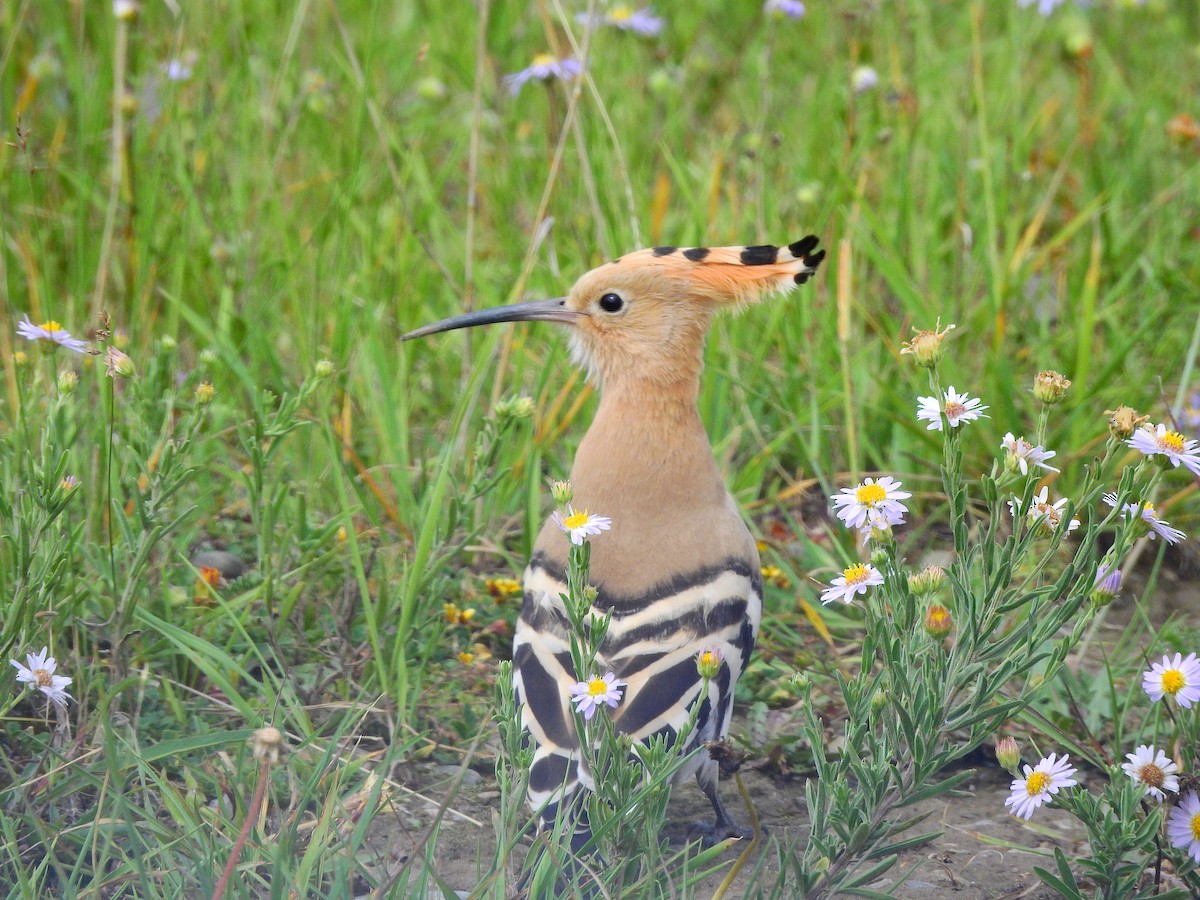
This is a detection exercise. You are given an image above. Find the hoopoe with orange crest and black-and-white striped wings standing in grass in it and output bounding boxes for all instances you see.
[404,235,824,846]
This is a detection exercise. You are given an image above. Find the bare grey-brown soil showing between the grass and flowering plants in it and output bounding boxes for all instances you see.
[360,560,1200,900]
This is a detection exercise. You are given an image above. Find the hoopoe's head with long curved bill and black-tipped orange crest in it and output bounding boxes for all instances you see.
[404,235,824,386]
